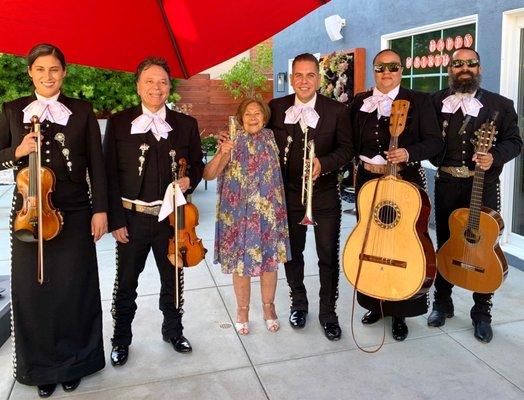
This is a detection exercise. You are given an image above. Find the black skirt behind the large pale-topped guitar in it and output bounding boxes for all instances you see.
[355,165,429,317]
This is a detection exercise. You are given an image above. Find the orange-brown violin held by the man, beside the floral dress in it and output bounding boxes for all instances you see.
[168,158,207,267]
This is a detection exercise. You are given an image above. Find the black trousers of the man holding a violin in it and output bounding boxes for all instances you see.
[111,210,183,345]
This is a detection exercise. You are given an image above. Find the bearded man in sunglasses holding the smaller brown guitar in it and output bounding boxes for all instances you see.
[428,49,522,343]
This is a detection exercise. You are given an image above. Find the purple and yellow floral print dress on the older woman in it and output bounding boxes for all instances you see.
[214,129,291,276]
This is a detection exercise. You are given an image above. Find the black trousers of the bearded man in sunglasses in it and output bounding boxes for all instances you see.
[433,171,500,322]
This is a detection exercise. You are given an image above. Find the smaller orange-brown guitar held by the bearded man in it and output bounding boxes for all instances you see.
[437,117,508,293]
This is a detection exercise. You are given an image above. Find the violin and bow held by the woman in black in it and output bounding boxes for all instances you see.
[14,116,64,284]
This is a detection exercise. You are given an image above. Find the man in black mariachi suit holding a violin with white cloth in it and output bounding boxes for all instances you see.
[104,57,204,366]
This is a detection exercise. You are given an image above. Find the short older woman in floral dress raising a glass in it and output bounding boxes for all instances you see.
[204,99,291,335]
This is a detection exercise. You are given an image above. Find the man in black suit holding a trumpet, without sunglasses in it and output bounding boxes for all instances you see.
[268,53,353,340]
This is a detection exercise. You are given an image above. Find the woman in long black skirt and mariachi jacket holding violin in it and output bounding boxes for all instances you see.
[0,44,107,397]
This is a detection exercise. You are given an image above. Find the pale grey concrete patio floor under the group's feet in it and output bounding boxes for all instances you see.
[0,182,524,400]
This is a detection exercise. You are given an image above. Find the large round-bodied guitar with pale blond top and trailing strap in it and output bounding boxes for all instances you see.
[343,100,435,301]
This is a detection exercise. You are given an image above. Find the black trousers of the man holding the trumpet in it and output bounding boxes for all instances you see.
[285,187,341,324]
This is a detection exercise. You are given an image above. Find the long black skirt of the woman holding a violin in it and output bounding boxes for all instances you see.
[11,205,105,385]
